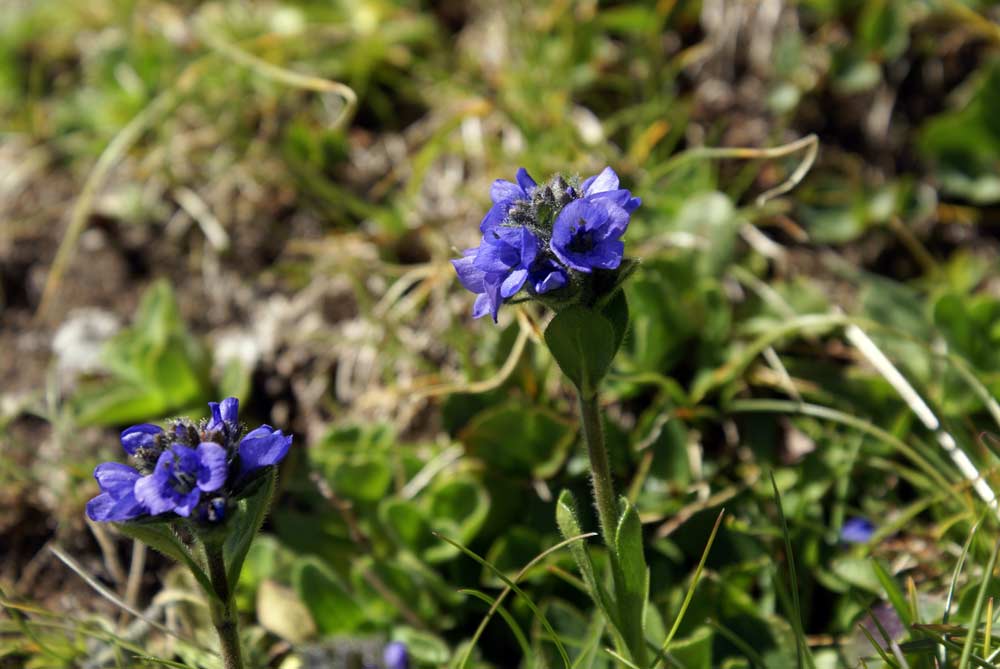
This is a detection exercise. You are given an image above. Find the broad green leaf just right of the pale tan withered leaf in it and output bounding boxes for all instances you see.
[292,558,366,635]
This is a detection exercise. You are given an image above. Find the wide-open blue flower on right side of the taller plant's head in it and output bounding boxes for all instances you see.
[551,197,629,272]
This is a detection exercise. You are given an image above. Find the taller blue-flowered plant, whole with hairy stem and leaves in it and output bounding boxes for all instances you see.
[452,167,649,668]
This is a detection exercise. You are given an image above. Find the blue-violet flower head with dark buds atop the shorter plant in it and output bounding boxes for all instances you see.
[87,397,292,522]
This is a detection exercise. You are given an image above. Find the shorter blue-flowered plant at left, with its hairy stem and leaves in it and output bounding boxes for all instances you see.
[87,397,292,669]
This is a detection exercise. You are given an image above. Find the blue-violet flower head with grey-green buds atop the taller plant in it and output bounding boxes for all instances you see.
[451,167,642,322]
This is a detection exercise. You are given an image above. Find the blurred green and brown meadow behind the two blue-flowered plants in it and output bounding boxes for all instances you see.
[0,0,1000,669]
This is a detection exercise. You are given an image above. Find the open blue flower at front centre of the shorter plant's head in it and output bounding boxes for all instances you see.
[135,442,229,517]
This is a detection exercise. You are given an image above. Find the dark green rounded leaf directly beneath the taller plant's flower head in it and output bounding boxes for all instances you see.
[545,306,616,397]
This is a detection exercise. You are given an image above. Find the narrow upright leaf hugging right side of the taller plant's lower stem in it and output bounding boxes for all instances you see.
[613,497,649,666]
